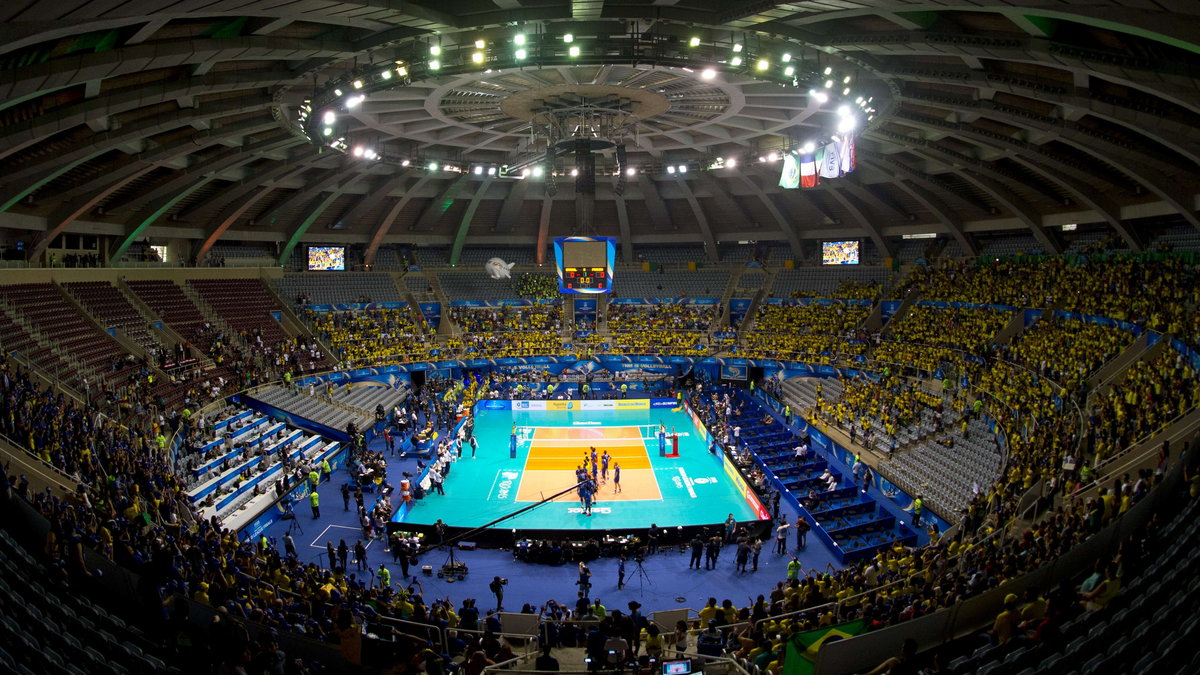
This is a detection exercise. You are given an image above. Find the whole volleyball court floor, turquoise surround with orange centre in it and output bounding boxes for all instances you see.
[397,399,766,530]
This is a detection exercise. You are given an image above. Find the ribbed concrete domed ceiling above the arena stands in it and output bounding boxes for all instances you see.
[0,0,1200,264]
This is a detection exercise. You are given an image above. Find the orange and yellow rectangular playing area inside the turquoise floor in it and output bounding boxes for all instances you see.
[516,426,662,503]
